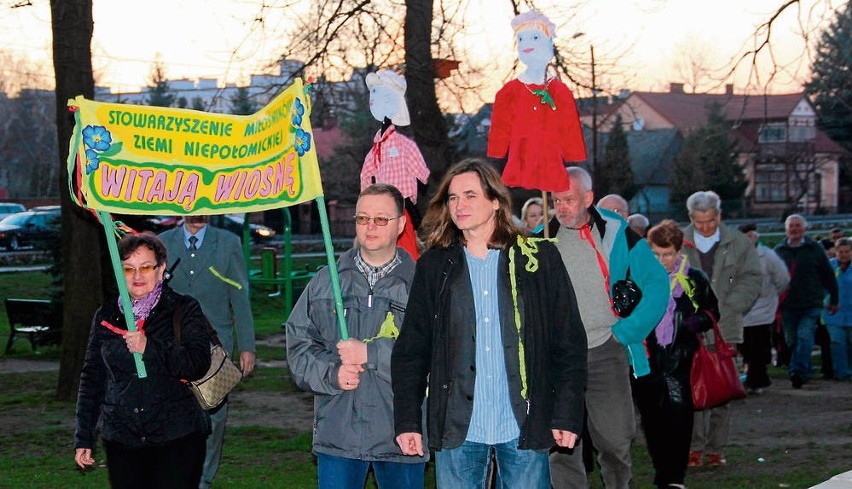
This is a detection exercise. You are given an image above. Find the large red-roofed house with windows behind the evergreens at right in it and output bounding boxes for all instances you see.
[596,83,846,216]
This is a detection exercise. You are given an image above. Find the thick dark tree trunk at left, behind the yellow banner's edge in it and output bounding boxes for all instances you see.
[50,0,103,400]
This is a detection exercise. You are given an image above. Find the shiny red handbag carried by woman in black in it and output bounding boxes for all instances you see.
[689,321,745,411]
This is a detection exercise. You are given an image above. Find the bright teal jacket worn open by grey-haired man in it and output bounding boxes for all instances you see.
[549,207,669,378]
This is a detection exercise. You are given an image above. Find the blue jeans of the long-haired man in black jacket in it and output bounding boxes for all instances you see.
[435,438,550,489]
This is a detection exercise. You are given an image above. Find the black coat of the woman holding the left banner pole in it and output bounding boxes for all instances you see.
[74,285,210,448]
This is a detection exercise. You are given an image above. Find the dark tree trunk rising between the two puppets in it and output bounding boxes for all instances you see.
[405,0,450,204]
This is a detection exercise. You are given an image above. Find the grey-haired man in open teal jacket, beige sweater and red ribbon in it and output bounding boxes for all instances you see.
[549,166,669,489]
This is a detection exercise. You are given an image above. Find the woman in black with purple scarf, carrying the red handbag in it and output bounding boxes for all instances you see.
[633,219,719,487]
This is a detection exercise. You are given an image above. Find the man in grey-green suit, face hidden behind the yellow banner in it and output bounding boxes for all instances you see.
[160,216,255,489]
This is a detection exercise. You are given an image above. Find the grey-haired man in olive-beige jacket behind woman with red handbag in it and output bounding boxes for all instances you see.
[682,190,763,467]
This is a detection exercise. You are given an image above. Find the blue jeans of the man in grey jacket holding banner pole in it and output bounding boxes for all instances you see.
[317,453,426,489]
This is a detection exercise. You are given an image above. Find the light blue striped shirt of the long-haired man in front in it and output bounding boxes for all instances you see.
[464,249,521,445]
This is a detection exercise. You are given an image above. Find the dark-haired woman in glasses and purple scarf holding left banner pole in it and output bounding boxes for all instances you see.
[74,234,210,488]
